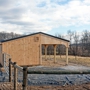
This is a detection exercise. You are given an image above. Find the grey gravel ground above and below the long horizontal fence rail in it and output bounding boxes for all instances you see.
[0,65,90,86]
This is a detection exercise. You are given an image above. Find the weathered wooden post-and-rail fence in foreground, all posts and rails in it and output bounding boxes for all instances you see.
[9,59,90,90]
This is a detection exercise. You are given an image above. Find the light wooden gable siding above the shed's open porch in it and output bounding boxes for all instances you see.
[41,34,69,47]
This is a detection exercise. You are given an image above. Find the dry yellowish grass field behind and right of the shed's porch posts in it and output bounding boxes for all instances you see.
[42,55,90,67]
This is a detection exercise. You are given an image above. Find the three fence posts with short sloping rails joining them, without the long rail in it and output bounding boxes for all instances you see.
[9,59,27,90]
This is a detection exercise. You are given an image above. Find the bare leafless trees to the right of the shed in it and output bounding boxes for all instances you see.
[68,30,90,57]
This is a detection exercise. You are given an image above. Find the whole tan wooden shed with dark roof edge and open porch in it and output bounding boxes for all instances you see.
[0,32,69,66]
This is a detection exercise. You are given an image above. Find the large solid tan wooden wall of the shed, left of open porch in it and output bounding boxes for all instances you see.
[2,34,41,66]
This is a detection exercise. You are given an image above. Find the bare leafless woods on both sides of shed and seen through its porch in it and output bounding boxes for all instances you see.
[0,30,90,57]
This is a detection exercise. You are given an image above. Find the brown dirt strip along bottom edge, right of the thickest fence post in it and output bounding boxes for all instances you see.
[28,83,90,90]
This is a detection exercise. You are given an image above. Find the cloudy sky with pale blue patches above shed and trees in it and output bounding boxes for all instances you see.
[0,0,90,35]
